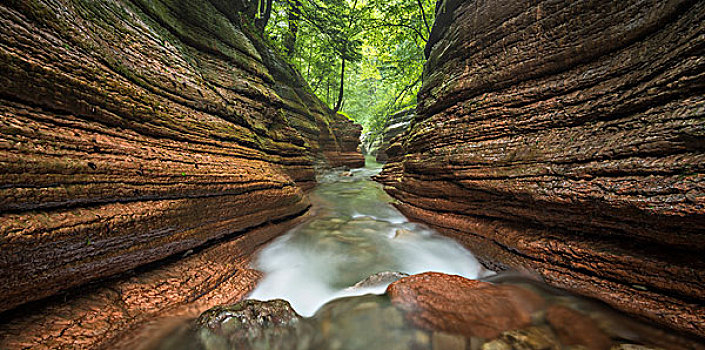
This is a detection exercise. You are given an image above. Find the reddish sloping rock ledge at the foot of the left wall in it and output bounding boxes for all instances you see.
[0,216,305,349]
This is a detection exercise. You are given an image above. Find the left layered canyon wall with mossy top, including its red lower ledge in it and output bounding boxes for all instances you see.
[0,0,363,348]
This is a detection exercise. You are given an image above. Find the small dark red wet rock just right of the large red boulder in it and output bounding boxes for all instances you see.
[546,305,612,350]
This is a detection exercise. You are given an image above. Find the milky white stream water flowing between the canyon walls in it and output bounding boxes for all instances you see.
[250,162,492,316]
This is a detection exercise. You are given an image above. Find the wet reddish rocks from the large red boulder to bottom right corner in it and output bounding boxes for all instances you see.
[387,272,705,350]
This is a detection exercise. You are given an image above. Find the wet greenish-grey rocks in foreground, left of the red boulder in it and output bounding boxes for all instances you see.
[157,295,430,350]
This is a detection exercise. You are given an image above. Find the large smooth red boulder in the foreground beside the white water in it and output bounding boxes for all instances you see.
[387,272,544,339]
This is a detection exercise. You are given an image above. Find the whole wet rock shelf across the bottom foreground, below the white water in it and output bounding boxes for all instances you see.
[147,273,703,350]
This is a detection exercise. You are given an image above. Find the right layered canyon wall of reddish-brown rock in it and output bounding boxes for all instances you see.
[378,0,705,337]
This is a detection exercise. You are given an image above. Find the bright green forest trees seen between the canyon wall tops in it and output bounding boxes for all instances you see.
[255,0,435,131]
